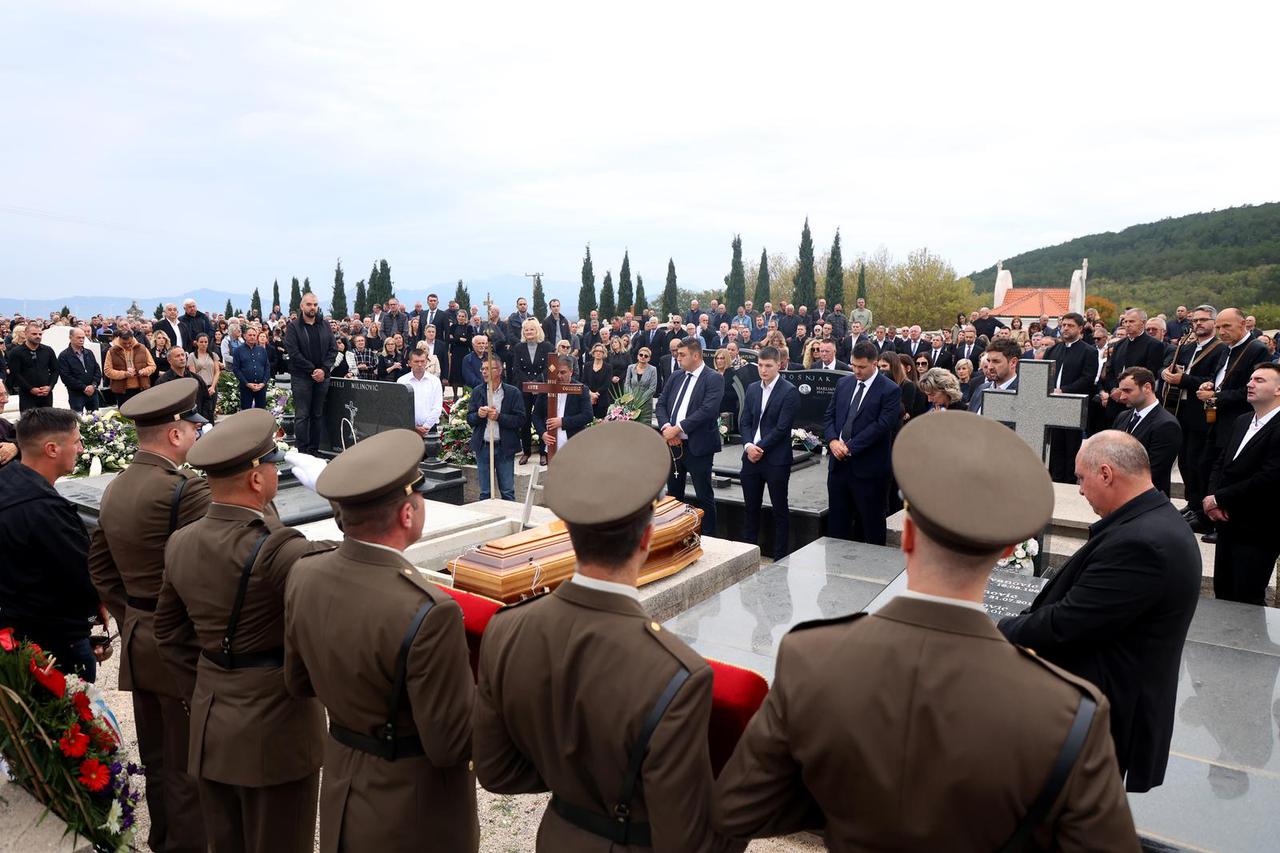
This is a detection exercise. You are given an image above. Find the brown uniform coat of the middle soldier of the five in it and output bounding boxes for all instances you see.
[284,539,480,853]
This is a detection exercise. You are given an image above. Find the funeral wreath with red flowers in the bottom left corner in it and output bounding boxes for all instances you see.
[0,628,142,852]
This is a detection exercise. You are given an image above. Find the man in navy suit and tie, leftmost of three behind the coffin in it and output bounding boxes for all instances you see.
[657,337,724,537]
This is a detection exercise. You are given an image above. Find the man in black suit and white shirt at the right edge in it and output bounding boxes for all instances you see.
[1203,361,1280,605]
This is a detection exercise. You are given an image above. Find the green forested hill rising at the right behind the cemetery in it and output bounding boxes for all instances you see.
[969,202,1280,292]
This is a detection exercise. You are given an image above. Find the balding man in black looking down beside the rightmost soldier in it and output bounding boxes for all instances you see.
[1000,430,1201,793]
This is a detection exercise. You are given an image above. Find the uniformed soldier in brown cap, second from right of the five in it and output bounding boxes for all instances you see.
[475,421,741,852]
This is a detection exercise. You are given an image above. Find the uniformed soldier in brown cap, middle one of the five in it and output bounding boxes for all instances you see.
[284,429,480,853]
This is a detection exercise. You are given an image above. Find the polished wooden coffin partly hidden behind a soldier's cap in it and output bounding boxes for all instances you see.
[445,497,703,605]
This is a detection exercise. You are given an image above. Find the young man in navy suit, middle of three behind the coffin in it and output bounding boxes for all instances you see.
[739,347,800,550]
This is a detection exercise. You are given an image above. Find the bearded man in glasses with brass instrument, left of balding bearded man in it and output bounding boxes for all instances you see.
[1161,305,1230,533]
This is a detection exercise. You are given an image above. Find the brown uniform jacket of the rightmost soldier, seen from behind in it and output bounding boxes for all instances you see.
[716,597,1139,853]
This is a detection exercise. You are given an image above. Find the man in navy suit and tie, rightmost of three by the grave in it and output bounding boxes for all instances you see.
[823,341,902,544]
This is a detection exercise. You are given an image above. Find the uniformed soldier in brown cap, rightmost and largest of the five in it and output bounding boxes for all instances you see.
[716,412,1139,852]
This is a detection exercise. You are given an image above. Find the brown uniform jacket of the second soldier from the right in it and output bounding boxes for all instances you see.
[475,581,742,853]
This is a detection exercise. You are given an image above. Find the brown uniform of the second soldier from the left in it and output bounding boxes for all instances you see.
[155,503,337,853]
